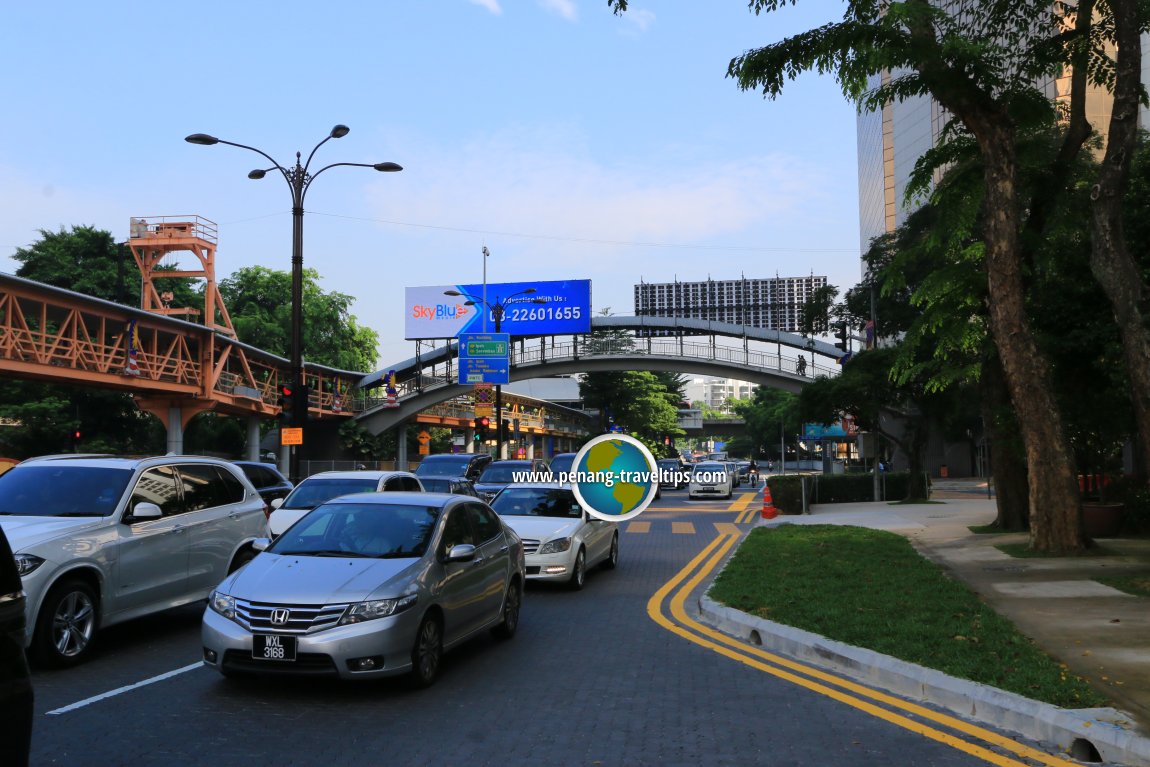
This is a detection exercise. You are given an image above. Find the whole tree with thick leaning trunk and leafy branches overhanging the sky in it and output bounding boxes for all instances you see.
[608,0,1122,553]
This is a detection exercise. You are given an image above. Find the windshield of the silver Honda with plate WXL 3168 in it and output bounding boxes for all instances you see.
[268,501,439,559]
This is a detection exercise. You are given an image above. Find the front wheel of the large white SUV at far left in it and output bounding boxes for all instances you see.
[32,581,97,668]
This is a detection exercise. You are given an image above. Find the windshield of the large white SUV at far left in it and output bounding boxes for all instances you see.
[0,461,132,516]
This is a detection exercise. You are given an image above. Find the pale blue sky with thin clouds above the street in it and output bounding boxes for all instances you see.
[0,0,860,368]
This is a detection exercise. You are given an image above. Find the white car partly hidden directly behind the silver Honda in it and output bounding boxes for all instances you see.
[491,483,619,589]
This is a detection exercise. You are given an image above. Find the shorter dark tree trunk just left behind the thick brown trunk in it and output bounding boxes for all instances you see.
[979,356,1030,531]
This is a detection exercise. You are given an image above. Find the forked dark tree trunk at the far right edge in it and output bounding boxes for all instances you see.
[1090,0,1150,483]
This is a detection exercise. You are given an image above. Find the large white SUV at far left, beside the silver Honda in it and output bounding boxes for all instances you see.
[0,455,267,666]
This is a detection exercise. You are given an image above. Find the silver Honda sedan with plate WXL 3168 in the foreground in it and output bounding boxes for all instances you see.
[202,492,526,687]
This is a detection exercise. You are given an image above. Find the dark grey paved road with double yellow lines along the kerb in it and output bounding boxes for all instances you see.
[32,491,1060,767]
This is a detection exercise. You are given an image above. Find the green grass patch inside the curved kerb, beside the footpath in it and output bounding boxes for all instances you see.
[711,524,1107,708]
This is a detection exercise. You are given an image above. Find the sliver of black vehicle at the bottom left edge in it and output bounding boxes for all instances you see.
[0,529,32,767]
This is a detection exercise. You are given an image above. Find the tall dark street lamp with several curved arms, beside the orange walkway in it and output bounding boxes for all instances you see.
[184,125,404,482]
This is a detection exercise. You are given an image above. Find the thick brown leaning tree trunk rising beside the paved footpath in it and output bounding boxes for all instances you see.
[967,128,1088,554]
